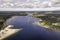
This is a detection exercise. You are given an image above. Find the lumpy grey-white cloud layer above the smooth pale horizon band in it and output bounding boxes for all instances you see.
[0,0,60,8]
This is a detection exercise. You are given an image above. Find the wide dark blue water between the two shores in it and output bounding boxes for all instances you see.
[5,16,60,40]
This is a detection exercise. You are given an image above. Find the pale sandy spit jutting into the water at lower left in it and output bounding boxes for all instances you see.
[0,27,22,40]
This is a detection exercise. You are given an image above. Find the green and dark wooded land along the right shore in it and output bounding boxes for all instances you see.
[33,14,60,30]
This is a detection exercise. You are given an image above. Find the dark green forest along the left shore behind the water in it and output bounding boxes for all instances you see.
[0,13,27,30]
